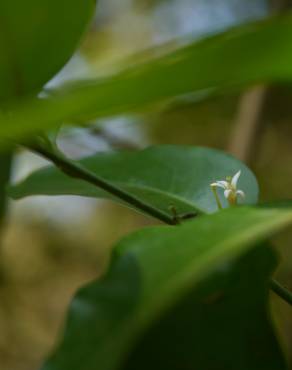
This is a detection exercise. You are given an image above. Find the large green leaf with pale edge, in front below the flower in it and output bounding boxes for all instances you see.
[43,207,292,370]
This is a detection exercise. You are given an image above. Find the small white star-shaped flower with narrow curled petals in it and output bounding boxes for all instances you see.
[211,171,245,208]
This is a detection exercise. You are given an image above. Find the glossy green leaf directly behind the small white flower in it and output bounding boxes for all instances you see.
[9,145,258,214]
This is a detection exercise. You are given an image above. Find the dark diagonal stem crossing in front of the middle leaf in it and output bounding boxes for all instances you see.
[25,141,177,225]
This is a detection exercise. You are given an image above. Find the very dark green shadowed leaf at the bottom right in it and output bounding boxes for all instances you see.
[123,246,287,370]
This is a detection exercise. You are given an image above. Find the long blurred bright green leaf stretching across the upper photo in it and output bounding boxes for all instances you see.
[0,14,292,136]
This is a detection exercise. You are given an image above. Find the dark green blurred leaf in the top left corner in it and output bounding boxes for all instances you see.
[0,0,95,101]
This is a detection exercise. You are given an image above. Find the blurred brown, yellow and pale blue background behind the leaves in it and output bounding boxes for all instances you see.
[0,0,292,370]
